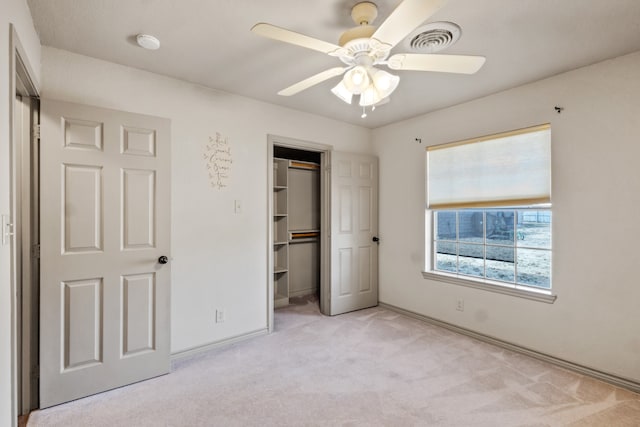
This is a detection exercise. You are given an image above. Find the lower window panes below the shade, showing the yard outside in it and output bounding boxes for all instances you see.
[432,209,551,289]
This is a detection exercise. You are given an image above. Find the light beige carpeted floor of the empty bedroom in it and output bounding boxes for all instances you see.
[29,299,640,427]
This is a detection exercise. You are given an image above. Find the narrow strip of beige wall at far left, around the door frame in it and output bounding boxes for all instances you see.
[0,0,40,426]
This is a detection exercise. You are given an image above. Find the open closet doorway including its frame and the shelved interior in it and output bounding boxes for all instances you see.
[268,136,331,331]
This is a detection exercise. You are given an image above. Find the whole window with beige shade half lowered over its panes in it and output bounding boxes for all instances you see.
[427,125,552,298]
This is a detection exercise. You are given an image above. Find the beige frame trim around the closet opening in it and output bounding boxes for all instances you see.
[267,134,333,332]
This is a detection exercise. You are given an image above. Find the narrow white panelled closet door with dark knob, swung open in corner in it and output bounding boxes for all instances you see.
[328,151,378,315]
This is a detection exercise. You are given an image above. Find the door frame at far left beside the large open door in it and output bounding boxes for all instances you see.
[9,24,39,425]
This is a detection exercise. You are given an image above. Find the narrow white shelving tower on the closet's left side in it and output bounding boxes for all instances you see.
[273,159,289,308]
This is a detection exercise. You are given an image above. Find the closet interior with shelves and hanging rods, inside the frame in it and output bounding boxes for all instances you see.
[273,146,321,308]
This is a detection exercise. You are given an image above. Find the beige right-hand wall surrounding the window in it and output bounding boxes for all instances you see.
[373,52,640,381]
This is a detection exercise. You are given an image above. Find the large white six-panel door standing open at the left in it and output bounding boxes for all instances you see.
[40,99,171,408]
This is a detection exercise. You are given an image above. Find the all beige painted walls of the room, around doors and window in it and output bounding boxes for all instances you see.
[5,5,640,418]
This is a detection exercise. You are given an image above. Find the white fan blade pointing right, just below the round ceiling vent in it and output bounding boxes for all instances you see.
[387,53,486,74]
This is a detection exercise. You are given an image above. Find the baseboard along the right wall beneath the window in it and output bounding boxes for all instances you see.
[378,302,640,393]
